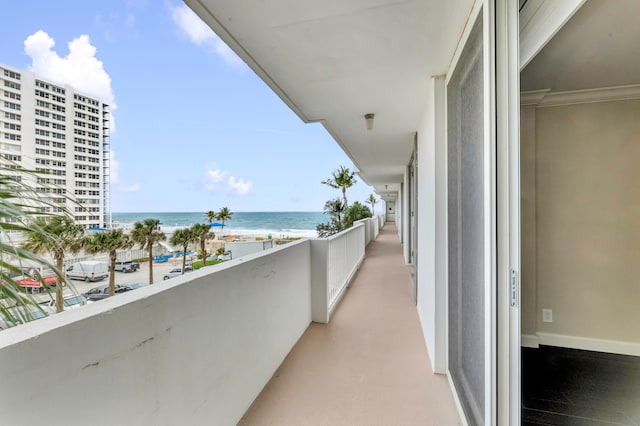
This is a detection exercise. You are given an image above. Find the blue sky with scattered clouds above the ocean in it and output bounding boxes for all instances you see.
[0,0,372,212]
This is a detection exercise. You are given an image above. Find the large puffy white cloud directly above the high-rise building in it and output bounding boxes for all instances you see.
[24,30,116,111]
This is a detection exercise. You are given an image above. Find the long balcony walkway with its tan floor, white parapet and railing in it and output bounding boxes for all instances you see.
[0,220,458,425]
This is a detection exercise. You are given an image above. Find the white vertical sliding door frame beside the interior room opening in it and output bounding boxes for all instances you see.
[494,0,521,426]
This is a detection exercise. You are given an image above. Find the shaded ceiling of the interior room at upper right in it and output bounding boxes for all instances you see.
[521,0,640,91]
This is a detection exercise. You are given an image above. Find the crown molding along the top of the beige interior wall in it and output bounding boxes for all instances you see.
[520,84,640,108]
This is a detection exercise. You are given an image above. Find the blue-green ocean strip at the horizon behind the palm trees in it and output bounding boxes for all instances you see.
[111,212,329,238]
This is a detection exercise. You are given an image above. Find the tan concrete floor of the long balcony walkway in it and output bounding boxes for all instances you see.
[239,223,460,426]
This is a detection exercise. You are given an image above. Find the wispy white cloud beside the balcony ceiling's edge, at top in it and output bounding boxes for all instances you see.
[171,4,243,66]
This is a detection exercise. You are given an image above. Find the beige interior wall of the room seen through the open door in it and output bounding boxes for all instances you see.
[522,100,640,355]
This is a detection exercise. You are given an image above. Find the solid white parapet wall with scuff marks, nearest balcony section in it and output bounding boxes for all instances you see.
[0,240,312,426]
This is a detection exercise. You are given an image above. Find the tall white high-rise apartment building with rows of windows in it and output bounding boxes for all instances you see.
[0,65,111,228]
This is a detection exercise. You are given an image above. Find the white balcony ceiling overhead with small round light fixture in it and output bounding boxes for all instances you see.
[185,0,473,195]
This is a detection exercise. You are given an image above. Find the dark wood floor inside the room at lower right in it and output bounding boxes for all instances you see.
[522,346,640,426]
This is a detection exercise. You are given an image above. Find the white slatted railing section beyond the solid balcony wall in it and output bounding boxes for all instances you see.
[311,223,365,323]
